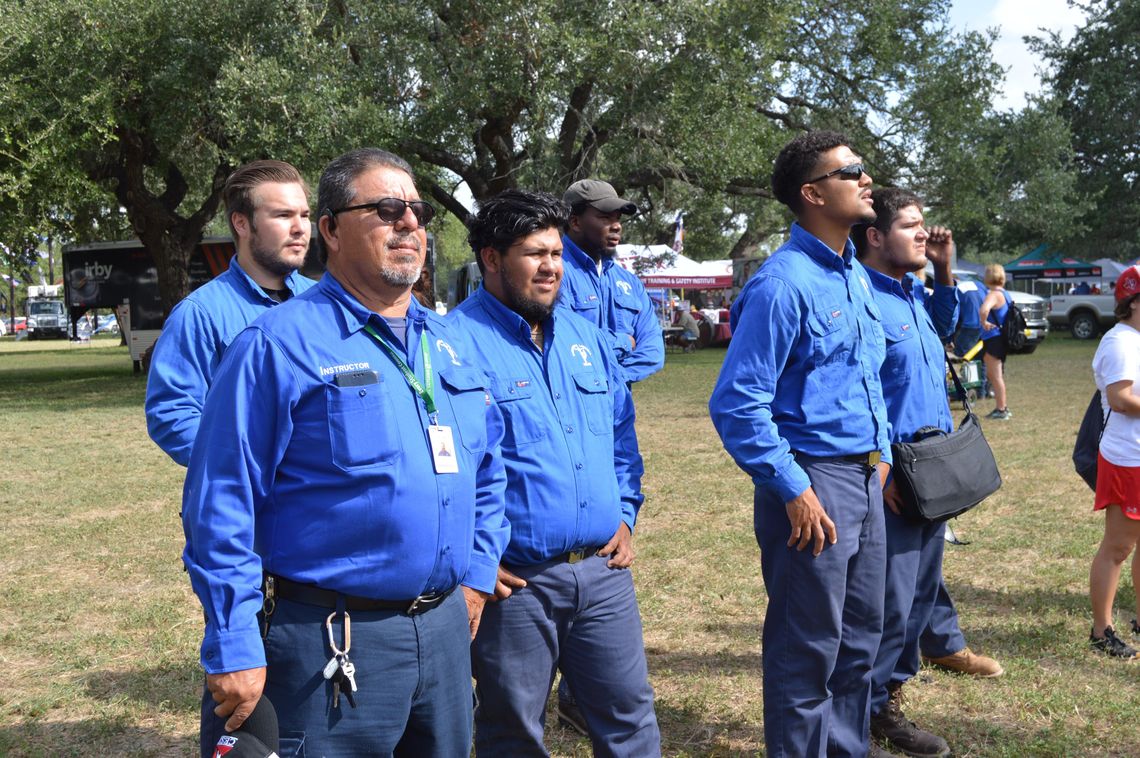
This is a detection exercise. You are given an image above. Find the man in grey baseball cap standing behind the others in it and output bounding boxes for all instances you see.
[559,179,665,383]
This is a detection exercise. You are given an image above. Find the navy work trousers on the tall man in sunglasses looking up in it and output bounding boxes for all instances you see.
[755,455,886,758]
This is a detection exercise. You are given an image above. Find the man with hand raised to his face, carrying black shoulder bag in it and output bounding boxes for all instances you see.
[852,188,1001,758]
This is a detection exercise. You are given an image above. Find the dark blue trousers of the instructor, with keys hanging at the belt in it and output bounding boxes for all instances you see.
[203,589,472,758]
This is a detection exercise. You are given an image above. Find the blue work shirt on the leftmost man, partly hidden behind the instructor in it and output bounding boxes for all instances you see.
[146,255,316,466]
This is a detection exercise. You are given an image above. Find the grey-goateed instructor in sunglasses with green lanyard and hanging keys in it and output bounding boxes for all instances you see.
[182,148,510,758]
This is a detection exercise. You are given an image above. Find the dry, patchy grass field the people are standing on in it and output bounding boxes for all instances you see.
[0,335,1140,756]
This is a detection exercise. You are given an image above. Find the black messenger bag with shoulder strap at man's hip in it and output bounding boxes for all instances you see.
[890,359,1001,523]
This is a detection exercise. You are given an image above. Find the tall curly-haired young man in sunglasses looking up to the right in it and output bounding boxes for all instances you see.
[709,132,890,757]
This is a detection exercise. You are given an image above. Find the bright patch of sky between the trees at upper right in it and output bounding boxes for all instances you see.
[950,0,1083,109]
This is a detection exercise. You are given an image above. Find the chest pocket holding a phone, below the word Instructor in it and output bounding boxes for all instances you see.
[325,377,400,470]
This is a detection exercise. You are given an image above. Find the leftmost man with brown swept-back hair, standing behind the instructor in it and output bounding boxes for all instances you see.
[146,161,314,466]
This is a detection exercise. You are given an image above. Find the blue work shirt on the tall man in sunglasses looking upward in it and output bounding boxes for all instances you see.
[709,223,890,503]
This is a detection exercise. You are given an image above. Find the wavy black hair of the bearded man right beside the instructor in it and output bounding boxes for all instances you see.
[467,189,570,271]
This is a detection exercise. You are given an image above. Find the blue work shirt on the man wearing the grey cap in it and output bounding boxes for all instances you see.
[559,236,665,382]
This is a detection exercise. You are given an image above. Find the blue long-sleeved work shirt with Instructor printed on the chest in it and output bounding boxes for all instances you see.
[182,274,510,674]
